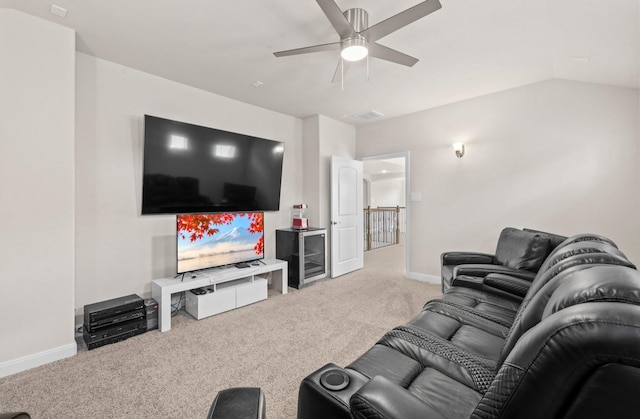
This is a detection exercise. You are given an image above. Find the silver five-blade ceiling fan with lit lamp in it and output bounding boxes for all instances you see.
[273,0,442,67]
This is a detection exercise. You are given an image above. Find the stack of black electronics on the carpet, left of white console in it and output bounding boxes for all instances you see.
[83,294,147,350]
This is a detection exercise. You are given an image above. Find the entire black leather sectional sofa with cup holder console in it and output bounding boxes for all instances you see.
[298,229,640,419]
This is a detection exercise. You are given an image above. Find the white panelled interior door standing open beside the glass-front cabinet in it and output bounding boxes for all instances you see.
[331,156,364,278]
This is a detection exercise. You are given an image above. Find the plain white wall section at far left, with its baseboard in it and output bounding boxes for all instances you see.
[0,9,76,377]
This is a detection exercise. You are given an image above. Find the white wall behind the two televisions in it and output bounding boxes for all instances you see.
[75,53,302,311]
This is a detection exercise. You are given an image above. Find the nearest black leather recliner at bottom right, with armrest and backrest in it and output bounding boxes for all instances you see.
[349,266,640,419]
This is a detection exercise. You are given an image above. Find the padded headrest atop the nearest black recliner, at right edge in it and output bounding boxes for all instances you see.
[542,265,640,319]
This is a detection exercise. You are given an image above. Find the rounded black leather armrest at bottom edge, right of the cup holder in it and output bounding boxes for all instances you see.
[349,376,446,419]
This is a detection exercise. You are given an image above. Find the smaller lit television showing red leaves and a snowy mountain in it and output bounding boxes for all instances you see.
[176,212,264,274]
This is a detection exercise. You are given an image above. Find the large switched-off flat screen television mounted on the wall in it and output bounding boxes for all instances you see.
[142,115,284,214]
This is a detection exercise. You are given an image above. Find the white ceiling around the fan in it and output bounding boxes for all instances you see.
[0,0,640,125]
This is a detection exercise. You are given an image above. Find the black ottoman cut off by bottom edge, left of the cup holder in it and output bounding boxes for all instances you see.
[207,387,266,419]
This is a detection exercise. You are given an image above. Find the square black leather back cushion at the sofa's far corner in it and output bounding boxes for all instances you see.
[495,227,549,272]
